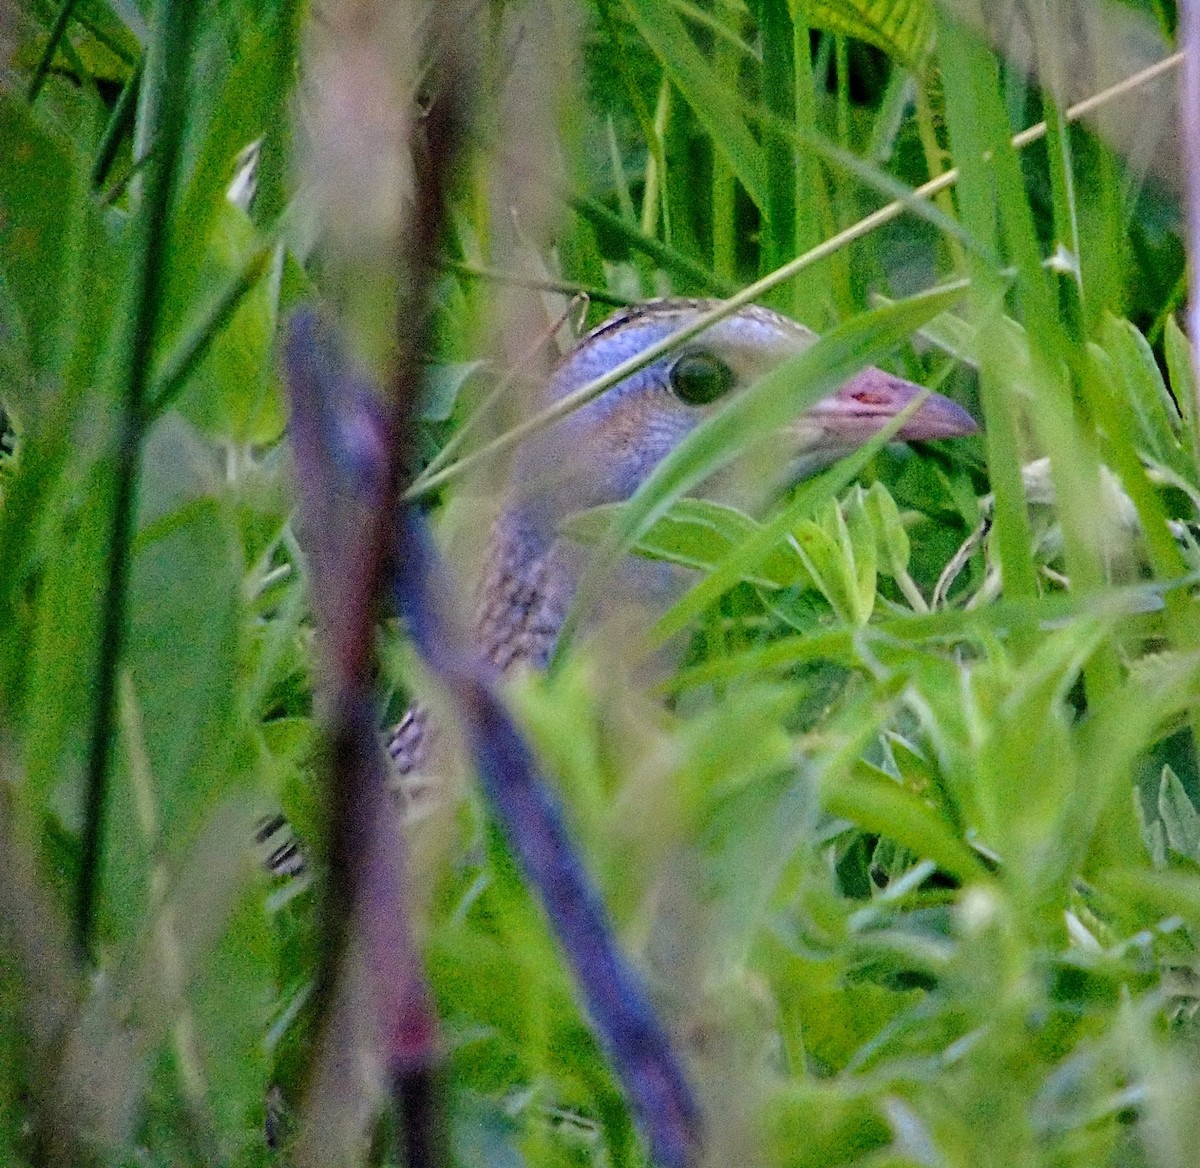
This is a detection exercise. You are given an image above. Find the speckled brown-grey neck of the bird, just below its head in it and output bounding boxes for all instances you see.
[475,508,577,672]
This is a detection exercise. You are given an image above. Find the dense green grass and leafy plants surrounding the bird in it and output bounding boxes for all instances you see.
[0,0,1200,1168]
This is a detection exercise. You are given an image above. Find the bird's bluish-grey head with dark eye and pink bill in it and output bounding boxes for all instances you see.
[517,300,977,521]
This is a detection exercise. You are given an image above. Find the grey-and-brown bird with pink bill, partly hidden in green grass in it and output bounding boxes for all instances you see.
[258,299,978,875]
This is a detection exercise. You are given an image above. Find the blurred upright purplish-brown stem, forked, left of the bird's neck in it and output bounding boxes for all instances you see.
[286,18,476,1168]
